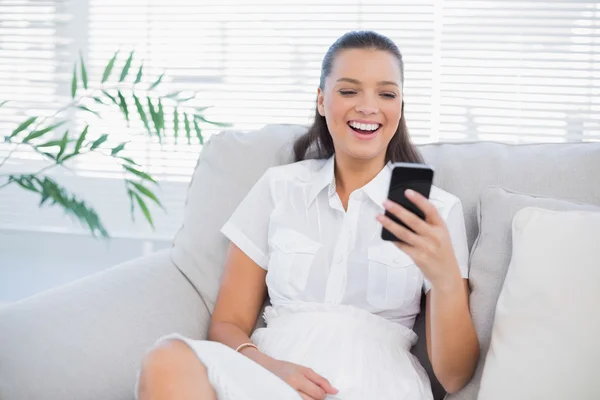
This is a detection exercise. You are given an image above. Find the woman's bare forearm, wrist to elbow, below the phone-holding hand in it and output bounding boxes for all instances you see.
[426,275,479,393]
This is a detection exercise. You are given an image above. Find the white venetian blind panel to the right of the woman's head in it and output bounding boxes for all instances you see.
[439,0,600,142]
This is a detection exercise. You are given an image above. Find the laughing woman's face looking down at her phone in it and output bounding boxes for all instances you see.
[317,49,402,162]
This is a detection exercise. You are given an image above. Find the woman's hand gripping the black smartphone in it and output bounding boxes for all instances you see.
[377,189,460,287]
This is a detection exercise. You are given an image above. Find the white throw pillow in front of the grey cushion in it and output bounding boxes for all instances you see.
[479,207,600,400]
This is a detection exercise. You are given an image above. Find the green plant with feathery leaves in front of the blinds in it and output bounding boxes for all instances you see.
[0,51,229,237]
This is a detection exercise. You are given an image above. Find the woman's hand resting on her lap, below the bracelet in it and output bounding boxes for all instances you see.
[264,359,338,400]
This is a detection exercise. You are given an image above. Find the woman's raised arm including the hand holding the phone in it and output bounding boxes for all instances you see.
[377,191,479,393]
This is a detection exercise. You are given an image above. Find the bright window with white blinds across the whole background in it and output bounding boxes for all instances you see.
[0,0,600,238]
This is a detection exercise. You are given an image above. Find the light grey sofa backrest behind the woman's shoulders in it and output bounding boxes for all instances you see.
[172,125,600,397]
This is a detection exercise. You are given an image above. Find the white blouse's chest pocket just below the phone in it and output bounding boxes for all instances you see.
[367,242,423,310]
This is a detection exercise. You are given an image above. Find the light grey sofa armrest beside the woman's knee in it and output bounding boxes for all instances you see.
[0,250,210,400]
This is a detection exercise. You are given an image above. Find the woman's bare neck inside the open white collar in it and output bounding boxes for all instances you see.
[335,154,385,208]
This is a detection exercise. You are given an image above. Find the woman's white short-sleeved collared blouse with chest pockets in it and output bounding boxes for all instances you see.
[221,157,469,329]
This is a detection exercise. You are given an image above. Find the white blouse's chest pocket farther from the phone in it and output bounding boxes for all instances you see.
[269,229,321,293]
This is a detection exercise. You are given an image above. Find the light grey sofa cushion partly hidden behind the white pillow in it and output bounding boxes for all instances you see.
[449,187,600,400]
